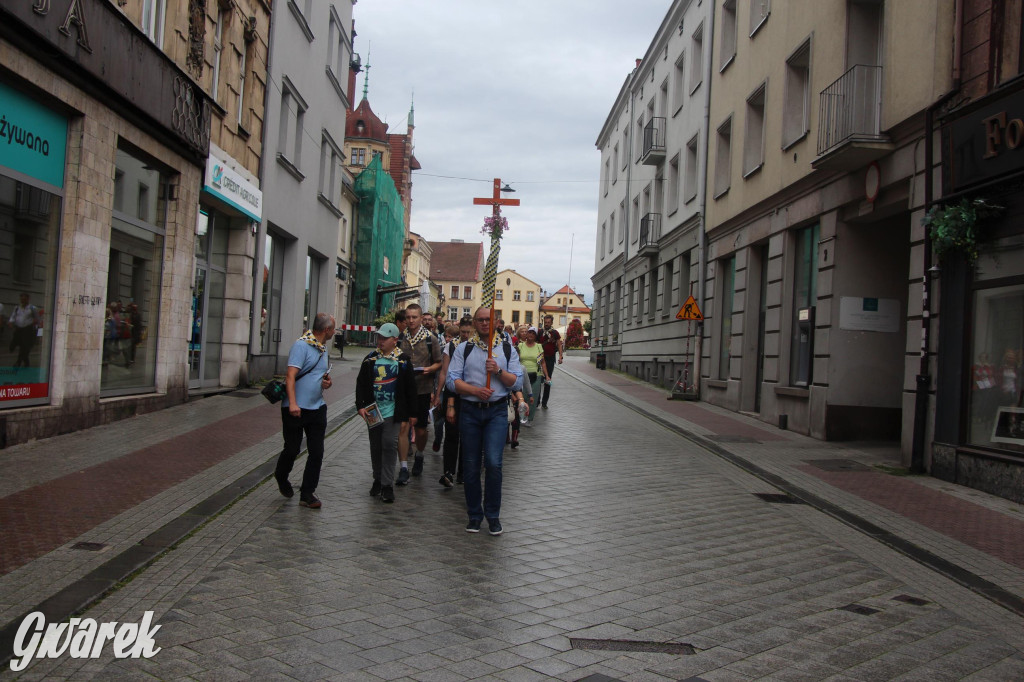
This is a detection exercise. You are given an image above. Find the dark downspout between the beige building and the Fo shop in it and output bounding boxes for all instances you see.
[910,0,964,473]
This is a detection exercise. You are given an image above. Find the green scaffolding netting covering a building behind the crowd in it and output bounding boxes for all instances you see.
[351,155,406,324]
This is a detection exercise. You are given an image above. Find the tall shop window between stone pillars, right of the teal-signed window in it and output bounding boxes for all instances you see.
[99,148,167,395]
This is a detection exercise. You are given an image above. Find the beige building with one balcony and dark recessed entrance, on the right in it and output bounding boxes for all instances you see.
[700,0,954,452]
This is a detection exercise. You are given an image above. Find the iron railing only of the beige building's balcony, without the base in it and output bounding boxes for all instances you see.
[818,65,882,156]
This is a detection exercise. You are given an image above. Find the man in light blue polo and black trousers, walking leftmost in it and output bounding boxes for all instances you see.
[273,312,335,509]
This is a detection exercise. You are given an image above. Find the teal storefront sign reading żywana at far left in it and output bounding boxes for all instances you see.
[0,83,68,187]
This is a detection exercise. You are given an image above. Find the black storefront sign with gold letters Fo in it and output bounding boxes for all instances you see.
[942,84,1024,193]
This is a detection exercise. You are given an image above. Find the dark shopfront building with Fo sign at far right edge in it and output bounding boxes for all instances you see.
[928,0,1024,502]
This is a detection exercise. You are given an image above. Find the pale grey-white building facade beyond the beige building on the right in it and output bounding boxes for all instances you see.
[593,0,716,393]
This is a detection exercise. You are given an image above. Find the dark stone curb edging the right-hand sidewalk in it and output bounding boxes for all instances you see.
[563,370,1024,616]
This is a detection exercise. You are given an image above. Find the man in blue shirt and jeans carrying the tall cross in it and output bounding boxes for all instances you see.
[445,307,522,536]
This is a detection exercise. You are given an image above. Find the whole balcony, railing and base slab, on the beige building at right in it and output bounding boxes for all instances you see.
[811,65,894,170]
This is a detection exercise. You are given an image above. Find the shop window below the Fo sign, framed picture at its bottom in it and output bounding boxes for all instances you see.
[967,236,1024,454]
